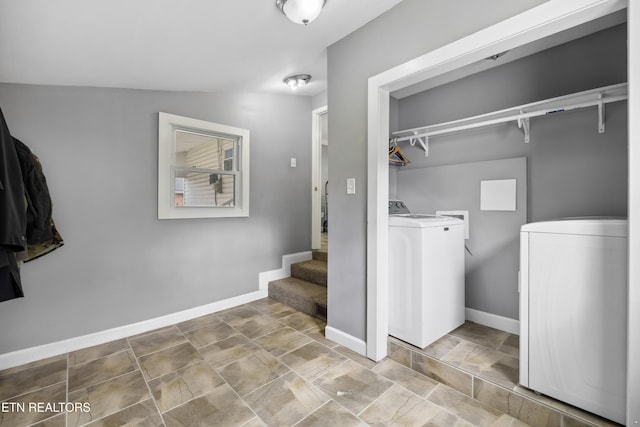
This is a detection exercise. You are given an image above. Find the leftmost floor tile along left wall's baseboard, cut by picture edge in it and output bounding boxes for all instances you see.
[0,356,67,401]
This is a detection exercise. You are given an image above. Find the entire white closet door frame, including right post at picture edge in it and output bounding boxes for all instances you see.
[366,0,640,425]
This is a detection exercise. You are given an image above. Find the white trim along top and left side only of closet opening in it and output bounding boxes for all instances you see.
[366,0,631,361]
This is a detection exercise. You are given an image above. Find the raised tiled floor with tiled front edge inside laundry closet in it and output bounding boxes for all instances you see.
[388,322,618,427]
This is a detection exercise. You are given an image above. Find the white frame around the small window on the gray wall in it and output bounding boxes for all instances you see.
[158,112,250,219]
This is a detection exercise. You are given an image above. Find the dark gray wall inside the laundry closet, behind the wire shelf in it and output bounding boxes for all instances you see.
[397,25,628,319]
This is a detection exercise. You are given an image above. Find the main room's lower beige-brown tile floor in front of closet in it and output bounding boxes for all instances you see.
[0,298,526,427]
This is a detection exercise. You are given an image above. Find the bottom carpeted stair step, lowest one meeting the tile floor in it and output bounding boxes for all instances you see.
[269,278,327,320]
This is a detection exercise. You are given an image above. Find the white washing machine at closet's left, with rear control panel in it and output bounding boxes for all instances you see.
[389,201,465,348]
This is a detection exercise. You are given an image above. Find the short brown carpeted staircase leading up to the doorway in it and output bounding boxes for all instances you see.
[269,251,327,321]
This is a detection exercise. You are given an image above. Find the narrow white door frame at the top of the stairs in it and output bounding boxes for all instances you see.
[311,105,329,249]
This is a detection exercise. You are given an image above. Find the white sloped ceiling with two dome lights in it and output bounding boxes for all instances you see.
[0,0,402,95]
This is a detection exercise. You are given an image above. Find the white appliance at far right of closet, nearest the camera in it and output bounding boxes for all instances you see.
[520,218,627,424]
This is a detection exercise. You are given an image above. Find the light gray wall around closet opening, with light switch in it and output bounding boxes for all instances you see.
[328,0,544,340]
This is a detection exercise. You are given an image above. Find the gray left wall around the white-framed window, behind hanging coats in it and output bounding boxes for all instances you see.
[0,84,311,353]
